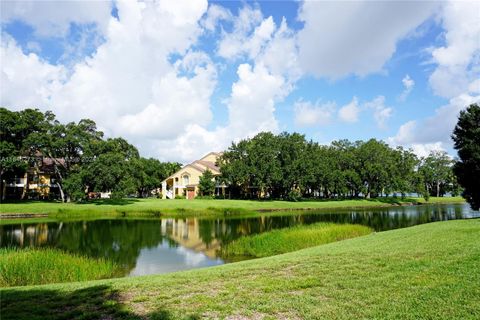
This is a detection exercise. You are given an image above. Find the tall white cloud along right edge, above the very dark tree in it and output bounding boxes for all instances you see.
[389,1,480,155]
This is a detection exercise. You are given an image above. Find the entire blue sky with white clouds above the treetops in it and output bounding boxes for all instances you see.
[0,0,480,162]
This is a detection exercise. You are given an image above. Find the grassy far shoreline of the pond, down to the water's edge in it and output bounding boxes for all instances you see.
[0,197,466,220]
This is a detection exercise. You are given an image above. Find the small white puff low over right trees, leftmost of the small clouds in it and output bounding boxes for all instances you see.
[294,100,336,127]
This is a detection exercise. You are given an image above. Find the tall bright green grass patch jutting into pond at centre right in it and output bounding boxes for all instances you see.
[222,223,372,258]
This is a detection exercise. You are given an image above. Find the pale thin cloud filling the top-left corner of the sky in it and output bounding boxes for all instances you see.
[0,0,112,37]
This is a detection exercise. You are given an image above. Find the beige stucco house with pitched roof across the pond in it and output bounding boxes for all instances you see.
[162,152,225,199]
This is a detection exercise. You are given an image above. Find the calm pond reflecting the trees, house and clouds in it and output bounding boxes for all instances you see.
[0,204,480,276]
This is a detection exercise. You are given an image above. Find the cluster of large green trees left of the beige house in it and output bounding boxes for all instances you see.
[0,108,181,201]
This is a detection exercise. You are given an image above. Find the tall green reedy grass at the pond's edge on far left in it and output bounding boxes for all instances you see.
[0,248,117,287]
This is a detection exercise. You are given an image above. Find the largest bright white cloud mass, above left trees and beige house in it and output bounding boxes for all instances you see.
[0,1,216,160]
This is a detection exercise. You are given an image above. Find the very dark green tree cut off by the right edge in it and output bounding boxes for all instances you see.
[452,104,480,210]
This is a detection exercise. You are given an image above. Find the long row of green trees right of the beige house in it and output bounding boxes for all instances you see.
[219,132,461,200]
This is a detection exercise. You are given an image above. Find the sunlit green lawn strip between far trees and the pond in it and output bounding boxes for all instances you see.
[0,197,464,217]
